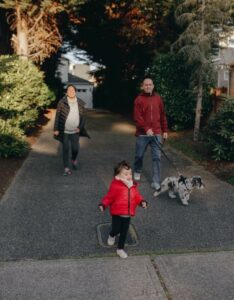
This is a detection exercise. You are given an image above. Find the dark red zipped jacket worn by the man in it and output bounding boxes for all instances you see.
[134,93,167,136]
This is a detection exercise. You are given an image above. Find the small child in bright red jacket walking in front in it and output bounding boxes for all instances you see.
[99,161,147,258]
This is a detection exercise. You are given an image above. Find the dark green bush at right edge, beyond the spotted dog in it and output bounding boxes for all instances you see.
[204,99,234,161]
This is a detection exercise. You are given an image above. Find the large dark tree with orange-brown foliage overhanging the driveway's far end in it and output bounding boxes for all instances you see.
[63,0,176,111]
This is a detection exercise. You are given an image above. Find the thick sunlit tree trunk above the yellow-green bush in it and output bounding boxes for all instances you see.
[15,5,29,59]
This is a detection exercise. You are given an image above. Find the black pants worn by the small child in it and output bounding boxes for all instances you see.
[110,216,130,249]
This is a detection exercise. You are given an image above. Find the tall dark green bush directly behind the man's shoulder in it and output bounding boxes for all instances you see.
[149,54,211,130]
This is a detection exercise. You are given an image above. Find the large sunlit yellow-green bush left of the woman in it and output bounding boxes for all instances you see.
[0,55,54,157]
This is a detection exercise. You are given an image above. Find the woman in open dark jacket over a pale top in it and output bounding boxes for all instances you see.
[54,85,89,176]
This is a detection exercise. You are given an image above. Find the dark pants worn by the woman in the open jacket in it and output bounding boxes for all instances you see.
[63,133,80,168]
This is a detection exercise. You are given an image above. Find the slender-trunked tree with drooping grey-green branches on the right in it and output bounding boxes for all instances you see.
[173,0,231,141]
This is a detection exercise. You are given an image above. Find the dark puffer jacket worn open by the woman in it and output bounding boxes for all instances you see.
[54,96,90,143]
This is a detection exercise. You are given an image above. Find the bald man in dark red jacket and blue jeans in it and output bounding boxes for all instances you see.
[134,77,168,191]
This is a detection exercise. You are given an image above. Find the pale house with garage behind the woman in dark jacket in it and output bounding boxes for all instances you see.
[56,57,94,108]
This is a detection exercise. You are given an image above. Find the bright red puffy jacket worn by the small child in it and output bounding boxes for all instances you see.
[101,178,144,216]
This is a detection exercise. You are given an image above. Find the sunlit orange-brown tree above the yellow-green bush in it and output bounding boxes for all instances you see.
[0,0,84,63]
